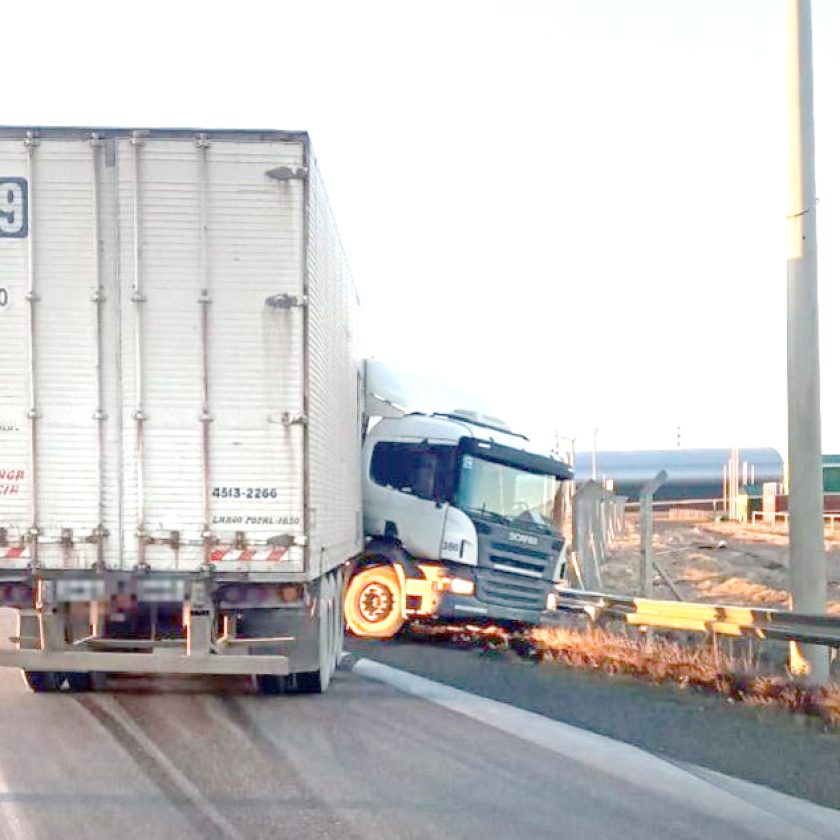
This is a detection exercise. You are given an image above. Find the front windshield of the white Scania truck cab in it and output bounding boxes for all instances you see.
[455,455,562,530]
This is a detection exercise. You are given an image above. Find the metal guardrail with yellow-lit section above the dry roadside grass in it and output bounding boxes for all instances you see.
[557,589,840,647]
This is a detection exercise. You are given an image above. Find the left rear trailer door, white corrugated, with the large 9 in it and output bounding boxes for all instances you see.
[0,134,118,568]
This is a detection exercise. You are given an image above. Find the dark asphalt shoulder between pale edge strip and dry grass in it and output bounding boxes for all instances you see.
[346,634,840,808]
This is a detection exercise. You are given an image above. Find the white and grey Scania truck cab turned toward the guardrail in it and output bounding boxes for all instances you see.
[344,411,572,638]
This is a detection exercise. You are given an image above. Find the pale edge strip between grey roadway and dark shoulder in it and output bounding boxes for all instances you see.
[353,659,840,840]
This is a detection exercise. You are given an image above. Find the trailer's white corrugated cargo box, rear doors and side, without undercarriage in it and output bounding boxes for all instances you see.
[0,129,361,577]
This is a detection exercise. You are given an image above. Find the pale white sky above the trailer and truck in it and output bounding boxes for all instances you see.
[6,0,840,452]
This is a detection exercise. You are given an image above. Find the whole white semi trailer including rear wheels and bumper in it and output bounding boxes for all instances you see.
[0,128,363,692]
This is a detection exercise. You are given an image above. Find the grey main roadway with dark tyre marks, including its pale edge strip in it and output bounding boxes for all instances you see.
[0,615,840,840]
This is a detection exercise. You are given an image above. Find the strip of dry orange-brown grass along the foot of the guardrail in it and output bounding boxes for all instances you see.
[418,626,840,729]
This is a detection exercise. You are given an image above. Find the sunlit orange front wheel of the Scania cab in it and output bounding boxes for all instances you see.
[344,566,405,639]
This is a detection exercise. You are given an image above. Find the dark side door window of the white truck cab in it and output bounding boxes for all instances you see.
[370,443,455,501]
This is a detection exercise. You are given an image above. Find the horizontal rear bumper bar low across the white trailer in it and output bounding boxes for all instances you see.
[0,650,290,676]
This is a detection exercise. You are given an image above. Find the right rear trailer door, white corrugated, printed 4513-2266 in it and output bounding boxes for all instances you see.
[112,136,303,571]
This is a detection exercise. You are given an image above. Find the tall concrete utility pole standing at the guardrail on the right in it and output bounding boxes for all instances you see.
[787,0,829,683]
